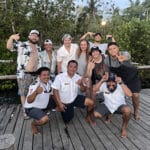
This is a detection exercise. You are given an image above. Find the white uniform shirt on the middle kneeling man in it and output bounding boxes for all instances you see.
[52,72,81,104]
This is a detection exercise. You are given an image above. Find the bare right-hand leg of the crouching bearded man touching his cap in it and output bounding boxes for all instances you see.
[121,105,131,138]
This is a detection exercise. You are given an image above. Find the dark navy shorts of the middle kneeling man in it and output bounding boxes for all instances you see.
[61,95,85,123]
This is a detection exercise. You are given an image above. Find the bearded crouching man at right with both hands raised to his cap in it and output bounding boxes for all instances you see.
[93,73,132,137]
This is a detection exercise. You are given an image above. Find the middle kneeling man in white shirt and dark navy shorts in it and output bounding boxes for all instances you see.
[52,60,94,124]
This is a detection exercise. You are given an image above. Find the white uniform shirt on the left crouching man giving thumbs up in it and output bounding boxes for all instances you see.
[24,80,52,109]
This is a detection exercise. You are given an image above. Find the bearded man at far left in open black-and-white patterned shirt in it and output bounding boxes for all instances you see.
[7,30,41,119]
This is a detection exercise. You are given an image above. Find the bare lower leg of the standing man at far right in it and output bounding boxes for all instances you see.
[132,93,140,120]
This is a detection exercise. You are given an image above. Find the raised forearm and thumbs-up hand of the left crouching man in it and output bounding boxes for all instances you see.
[27,85,43,103]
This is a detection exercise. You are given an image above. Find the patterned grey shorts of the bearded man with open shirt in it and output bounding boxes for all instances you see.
[17,73,36,96]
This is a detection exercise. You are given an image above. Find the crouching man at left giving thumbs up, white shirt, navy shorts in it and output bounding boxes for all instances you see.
[24,67,52,134]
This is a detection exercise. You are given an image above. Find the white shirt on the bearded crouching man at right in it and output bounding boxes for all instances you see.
[99,82,126,113]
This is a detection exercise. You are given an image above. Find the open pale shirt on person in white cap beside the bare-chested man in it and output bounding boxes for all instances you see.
[40,50,56,74]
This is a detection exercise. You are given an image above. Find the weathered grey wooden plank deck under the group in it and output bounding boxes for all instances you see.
[0,89,150,150]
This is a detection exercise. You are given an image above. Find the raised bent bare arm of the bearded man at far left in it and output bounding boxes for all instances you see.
[6,34,20,50]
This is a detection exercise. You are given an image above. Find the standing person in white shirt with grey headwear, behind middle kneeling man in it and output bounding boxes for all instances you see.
[57,34,78,73]
